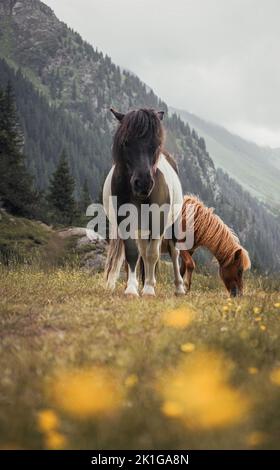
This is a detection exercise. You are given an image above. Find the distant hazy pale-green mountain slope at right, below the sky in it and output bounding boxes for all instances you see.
[171,108,280,209]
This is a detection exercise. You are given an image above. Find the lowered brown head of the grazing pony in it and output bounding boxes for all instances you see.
[220,247,251,297]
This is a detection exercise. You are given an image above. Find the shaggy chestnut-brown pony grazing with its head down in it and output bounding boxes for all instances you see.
[180,195,251,297]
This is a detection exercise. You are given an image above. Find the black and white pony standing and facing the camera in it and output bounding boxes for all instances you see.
[103,109,185,296]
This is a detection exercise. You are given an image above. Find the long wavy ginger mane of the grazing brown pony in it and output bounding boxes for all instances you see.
[182,195,251,271]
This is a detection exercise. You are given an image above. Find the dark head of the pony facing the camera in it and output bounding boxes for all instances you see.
[111,109,164,199]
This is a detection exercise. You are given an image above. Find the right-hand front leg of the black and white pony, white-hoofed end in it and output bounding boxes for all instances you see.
[139,239,161,296]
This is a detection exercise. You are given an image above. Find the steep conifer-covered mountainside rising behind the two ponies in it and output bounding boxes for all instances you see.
[0,0,280,270]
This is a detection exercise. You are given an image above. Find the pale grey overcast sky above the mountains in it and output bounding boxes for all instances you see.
[43,0,280,147]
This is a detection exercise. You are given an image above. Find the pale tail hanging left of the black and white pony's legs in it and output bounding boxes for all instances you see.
[105,236,124,290]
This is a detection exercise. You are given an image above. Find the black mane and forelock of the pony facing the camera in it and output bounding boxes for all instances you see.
[113,108,164,163]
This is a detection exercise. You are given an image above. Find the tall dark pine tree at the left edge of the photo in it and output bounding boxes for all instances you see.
[0,83,38,215]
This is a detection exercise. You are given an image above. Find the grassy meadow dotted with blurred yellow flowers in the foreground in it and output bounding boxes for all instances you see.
[0,266,280,449]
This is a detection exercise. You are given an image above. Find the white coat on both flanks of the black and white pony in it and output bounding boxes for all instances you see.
[103,154,183,230]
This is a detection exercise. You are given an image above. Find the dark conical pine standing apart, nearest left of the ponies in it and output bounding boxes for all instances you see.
[48,150,76,224]
